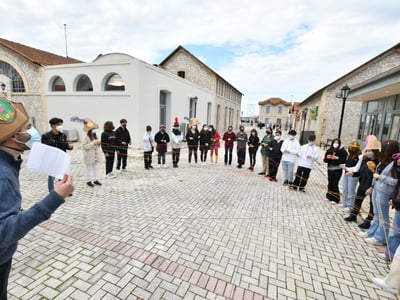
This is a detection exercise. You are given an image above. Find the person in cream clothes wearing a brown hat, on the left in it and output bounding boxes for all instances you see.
[82,118,101,187]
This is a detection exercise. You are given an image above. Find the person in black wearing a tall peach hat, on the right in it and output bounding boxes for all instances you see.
[344,135,381,229]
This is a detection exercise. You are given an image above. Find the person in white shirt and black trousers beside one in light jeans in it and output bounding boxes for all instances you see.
[289,134,319,192]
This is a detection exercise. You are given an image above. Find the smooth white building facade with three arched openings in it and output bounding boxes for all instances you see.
[44,53,216,148]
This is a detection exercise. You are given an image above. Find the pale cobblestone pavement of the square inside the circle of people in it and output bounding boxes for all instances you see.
[9,137,396,300]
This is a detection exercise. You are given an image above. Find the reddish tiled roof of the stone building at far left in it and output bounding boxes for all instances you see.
[0,38,82,66]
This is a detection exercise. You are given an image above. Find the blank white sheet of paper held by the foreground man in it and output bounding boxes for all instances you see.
[26,143,71,179]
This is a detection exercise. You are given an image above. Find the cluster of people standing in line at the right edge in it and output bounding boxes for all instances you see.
[324,135,400,294]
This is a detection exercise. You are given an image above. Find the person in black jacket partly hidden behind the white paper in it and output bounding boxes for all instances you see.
[42,118,74,192]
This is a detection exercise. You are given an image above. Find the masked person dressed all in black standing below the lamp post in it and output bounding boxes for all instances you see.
[324,138,347,203]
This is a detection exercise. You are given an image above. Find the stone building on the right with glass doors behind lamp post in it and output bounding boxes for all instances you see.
[297,44,400,145]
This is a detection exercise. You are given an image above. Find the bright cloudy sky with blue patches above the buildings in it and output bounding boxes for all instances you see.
[0,0,400,115]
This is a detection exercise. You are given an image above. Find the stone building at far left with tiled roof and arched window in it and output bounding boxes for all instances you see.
[0,38,80,131]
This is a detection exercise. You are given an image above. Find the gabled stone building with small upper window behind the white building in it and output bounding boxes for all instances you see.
[160,46,242,131]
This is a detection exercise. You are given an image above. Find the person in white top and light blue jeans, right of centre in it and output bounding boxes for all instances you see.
[281,129,300,185]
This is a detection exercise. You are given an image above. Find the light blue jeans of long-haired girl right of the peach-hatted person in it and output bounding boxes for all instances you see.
[367,189,390,244]
